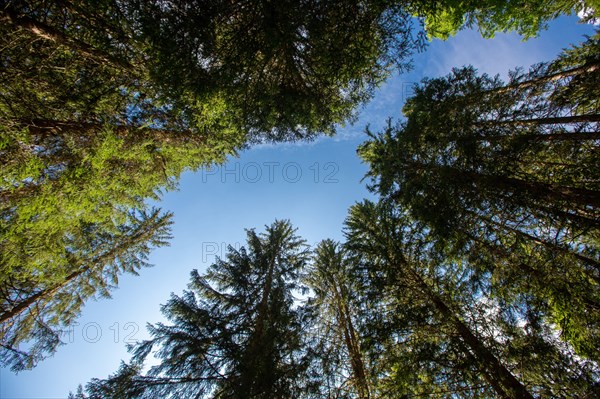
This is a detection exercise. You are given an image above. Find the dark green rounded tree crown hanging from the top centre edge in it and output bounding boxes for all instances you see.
[131,0,421,141]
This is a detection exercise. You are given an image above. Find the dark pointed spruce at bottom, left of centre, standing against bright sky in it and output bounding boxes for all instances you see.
[80,221,310,399]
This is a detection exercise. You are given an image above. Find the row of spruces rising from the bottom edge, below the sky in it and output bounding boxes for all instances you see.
[71,212,600,399]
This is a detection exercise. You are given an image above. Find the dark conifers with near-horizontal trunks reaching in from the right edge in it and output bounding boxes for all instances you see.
[359,35,600,360]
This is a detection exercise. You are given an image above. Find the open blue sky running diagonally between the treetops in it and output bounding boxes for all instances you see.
[0,17,594,399]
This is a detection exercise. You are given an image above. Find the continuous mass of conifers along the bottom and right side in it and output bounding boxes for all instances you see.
[72,34,600,399]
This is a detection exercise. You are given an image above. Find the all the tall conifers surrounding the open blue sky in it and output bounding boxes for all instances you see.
[0,0,600,398]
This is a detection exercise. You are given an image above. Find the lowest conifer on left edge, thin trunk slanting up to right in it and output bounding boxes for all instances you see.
[0,209,171,371]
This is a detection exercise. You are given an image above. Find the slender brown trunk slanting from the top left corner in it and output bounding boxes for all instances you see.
[0,6,134,72]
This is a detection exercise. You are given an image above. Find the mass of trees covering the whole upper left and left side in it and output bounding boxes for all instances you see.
[0,0,422,371]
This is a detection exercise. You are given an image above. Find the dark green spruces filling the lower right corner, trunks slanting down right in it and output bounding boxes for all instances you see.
[346,201,598,398]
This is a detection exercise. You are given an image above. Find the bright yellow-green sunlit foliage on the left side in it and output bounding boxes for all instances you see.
[0,124,236,369]
